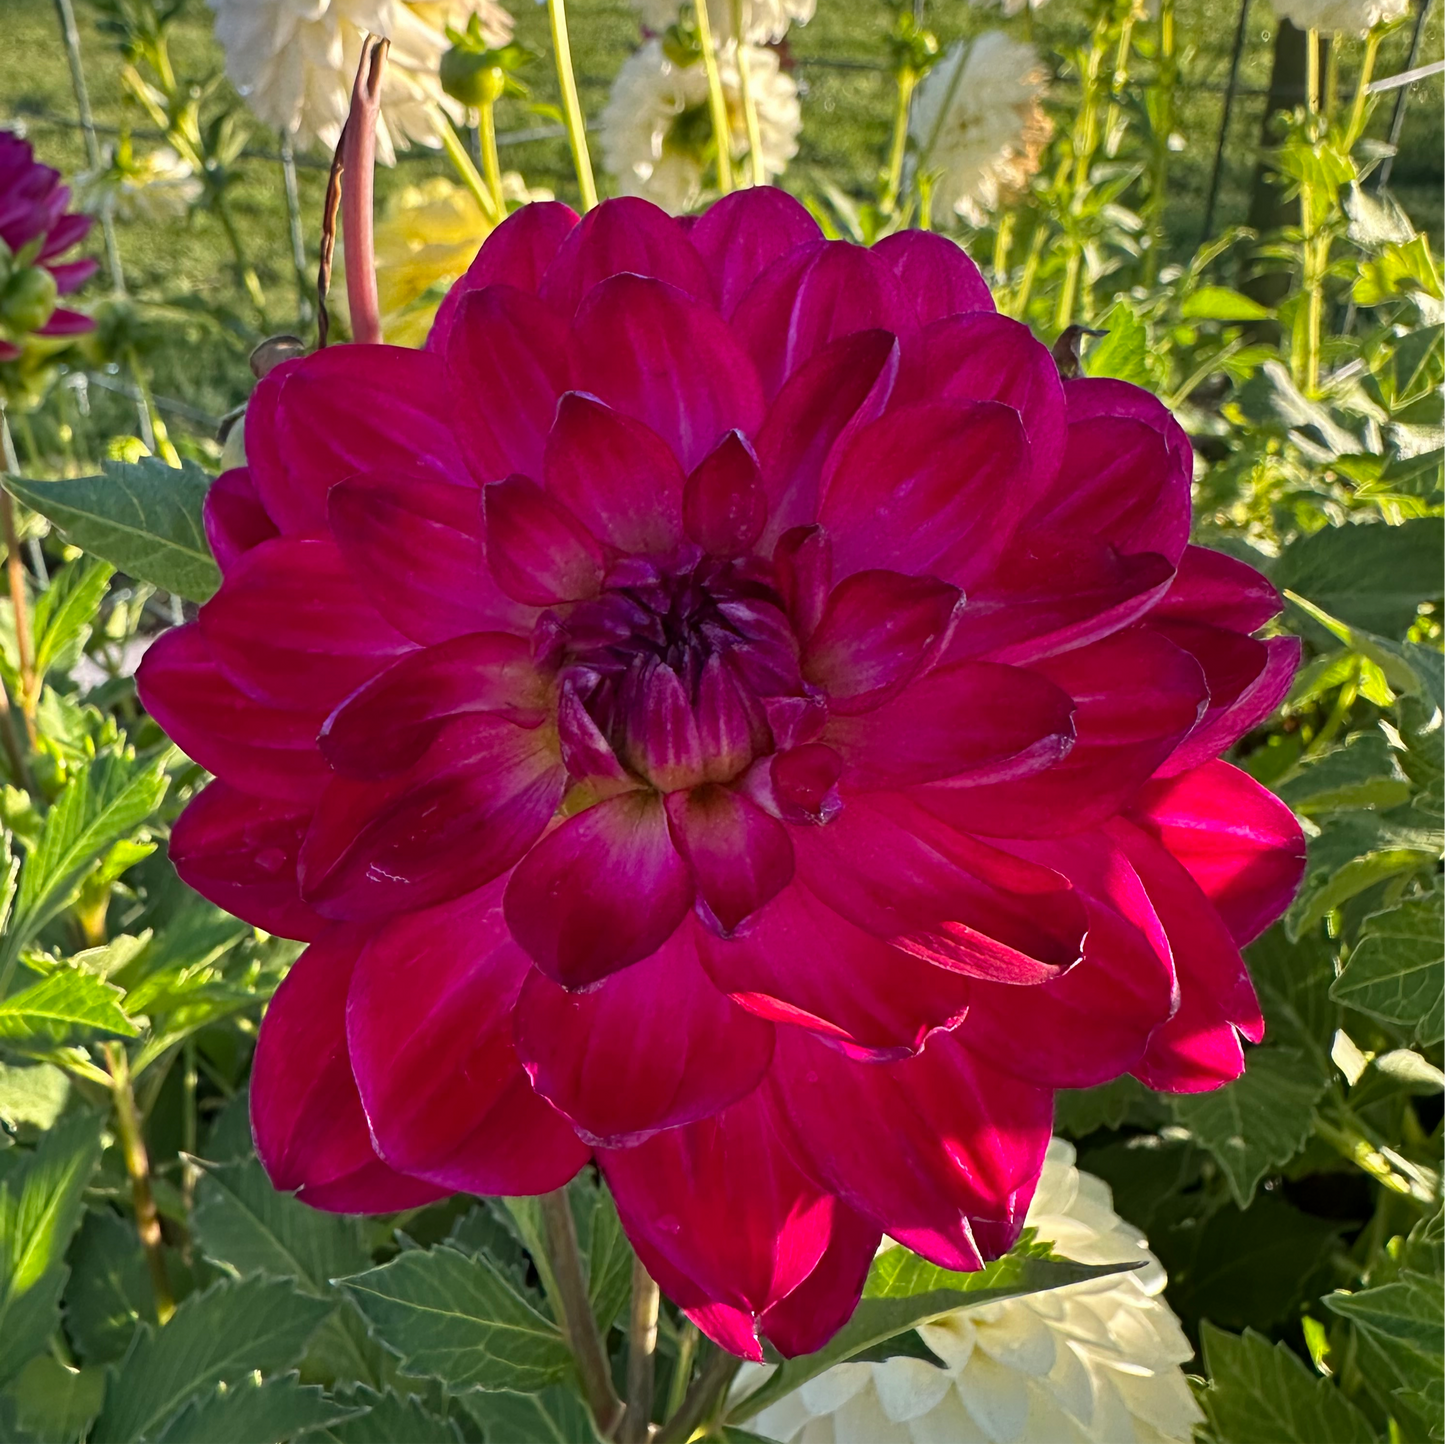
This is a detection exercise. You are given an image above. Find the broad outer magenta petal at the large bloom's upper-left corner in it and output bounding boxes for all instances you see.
[246,345,467,532]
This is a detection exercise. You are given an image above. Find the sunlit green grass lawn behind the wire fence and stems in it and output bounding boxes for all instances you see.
[0,0,1445,450]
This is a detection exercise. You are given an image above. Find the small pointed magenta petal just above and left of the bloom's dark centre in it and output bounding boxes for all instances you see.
[543,392,683,554]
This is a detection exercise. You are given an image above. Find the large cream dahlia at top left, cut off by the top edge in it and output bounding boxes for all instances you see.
[208,0,512,165]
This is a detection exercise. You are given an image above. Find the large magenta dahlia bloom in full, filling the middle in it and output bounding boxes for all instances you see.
[140,189,1303,1359]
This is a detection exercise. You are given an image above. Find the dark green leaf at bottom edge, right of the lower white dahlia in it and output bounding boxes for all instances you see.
[1201,1324,1377,1444]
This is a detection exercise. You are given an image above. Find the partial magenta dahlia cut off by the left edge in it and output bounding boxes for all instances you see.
[0,130,95,361]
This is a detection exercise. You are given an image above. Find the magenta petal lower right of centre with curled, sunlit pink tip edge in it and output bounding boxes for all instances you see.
[793,794,1087,987]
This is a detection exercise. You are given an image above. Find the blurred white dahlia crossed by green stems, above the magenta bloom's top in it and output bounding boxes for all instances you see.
[601,39,802,215]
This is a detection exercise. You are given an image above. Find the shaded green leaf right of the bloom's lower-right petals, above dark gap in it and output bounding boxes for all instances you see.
[1170,1048,1329,1208]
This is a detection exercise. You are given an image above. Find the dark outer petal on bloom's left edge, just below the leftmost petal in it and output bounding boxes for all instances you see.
[169,781,327,941]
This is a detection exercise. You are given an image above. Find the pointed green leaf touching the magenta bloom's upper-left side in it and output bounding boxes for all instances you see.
[4,457,221,601]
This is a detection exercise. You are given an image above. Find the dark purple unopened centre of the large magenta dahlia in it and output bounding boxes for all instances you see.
[538,558,806,792]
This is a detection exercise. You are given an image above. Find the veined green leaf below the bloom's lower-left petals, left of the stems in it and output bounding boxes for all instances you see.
[338,1245,572,1393]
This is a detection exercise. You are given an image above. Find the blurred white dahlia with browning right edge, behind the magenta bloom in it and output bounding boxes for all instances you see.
[909,30,1053,225]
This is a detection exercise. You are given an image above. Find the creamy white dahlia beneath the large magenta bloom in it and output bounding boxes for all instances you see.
[741,1139,1204,1444]
